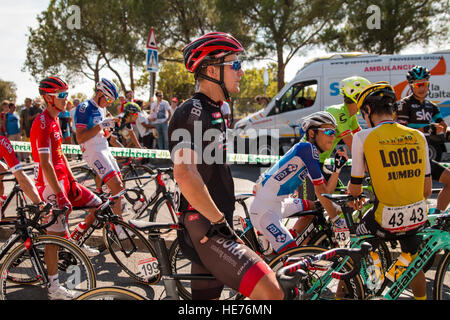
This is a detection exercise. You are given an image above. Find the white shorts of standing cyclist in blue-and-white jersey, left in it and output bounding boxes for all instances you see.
[83,148,120,183]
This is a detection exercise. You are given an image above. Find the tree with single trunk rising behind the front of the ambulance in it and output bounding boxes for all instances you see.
[216,0,343,90]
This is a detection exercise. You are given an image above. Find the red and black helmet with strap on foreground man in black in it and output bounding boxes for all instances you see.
[182,32,244,100]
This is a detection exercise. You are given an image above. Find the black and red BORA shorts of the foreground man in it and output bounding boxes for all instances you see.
[179,211,272,299]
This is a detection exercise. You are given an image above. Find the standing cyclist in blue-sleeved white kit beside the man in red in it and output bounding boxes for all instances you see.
[75,78,126,234]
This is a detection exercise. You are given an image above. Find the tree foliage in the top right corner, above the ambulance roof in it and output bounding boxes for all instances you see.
[321,0,449,54]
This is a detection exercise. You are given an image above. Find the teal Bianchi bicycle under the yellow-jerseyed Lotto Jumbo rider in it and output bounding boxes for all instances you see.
[274,195,450,300]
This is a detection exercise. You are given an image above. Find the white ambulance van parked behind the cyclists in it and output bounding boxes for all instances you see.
[231,50,450,159]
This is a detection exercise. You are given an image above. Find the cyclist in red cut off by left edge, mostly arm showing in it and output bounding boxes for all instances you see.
[0,136,41,204]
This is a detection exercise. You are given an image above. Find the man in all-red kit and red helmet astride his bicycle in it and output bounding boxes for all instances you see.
[30,77,101,299]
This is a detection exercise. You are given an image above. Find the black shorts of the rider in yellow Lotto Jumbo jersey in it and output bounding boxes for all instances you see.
[356,207,423,255]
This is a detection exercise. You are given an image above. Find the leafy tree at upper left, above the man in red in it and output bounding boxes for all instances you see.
[24,0,151,91]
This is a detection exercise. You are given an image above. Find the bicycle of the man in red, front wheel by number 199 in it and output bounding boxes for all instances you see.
[66,190,161,285]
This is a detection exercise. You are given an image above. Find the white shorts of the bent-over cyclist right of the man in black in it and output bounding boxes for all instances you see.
[250,196,309,253]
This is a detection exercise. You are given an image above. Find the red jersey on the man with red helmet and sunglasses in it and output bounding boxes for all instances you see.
[30,110,68,186]
